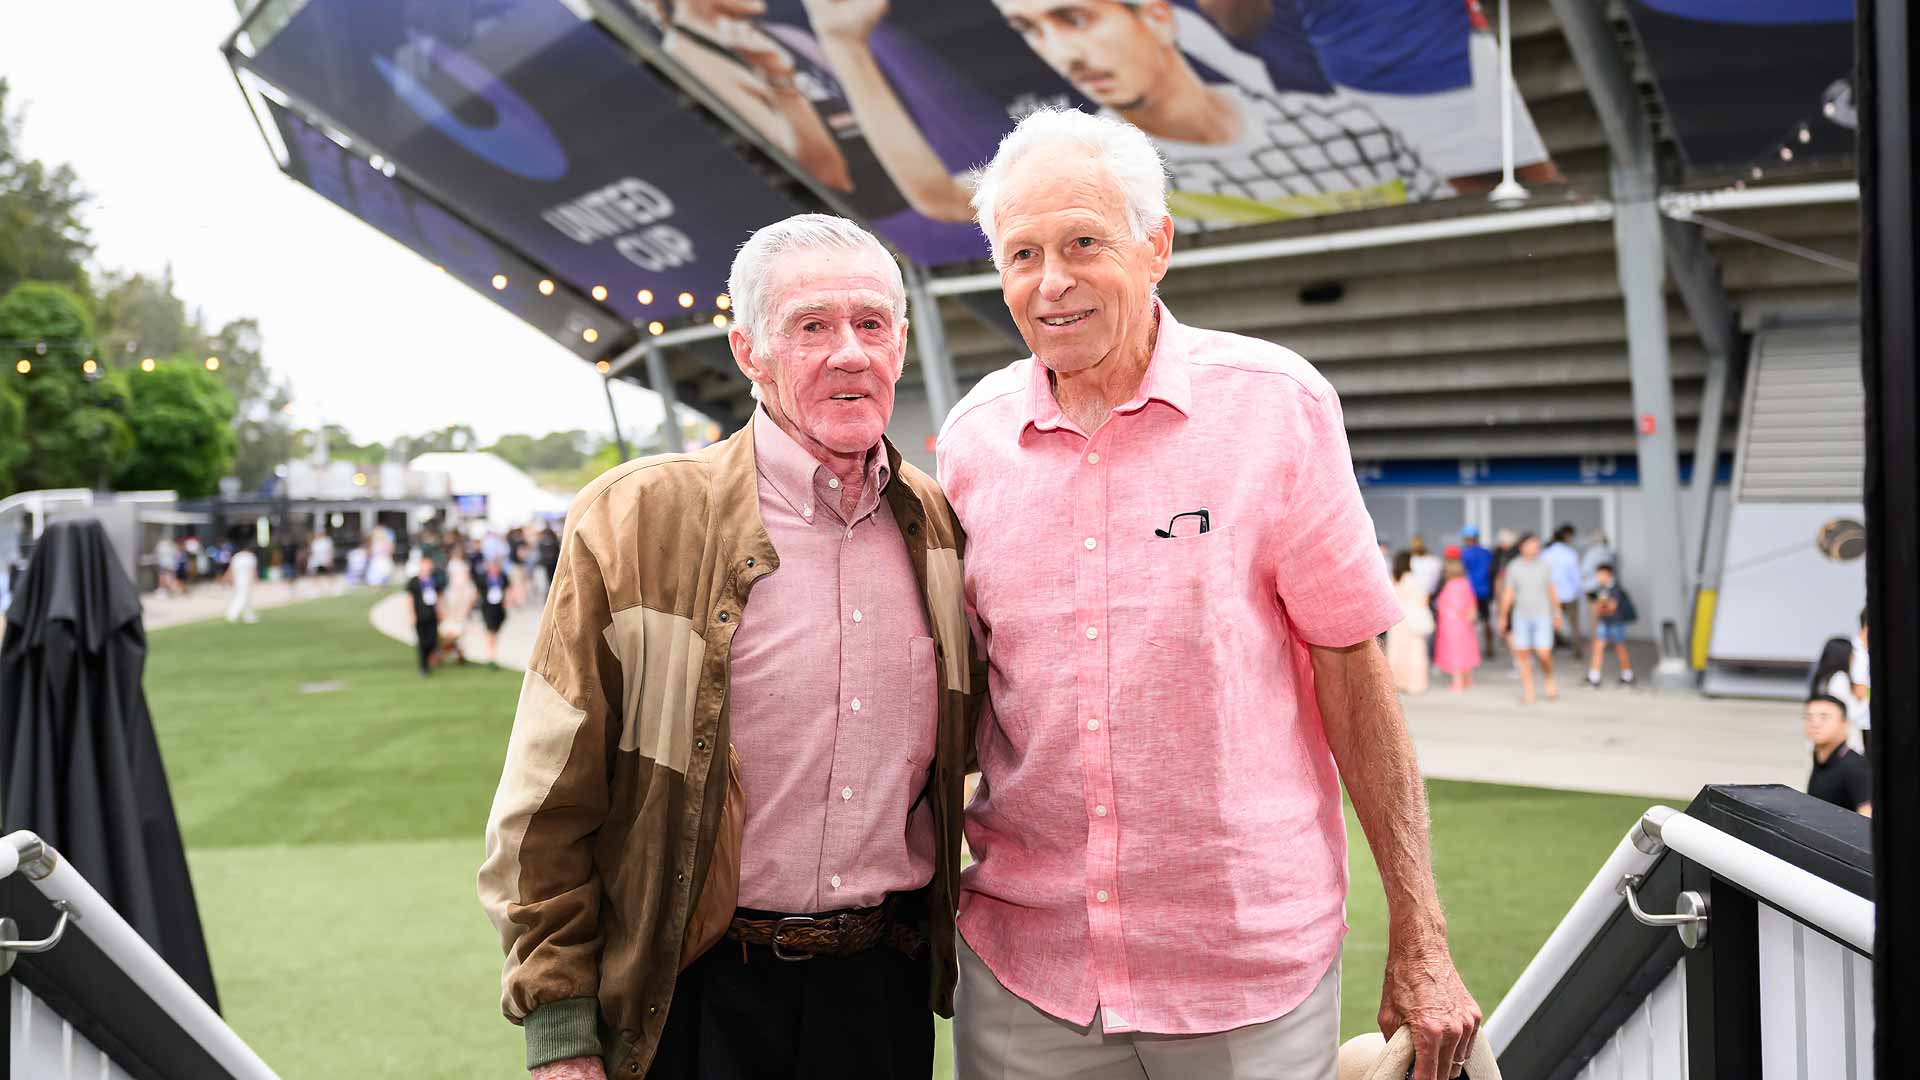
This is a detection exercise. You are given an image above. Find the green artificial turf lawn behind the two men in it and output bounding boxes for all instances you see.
[146,594,1647,1080]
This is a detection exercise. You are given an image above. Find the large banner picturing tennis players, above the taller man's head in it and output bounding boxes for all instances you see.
[591,0,1559,263]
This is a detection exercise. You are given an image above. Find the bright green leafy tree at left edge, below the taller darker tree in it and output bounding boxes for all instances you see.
[0,281,132,490]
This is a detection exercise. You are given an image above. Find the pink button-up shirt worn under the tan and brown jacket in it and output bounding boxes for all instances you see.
[730,411,935,915]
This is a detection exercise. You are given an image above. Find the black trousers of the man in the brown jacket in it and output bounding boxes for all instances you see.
[647,938,933,1080]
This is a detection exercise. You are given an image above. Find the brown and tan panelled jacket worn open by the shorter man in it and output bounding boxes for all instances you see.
[466,425,985,1076]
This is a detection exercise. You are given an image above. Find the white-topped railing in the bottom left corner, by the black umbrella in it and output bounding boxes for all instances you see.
[0,832,278,1080]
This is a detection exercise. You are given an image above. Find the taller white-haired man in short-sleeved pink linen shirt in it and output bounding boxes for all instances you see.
[937,110,1480,1080]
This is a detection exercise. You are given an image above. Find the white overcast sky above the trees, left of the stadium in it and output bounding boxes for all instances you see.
[0,0,660,442]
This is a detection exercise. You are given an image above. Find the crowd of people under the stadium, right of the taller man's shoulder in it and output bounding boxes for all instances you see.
[1380,525,1640,705]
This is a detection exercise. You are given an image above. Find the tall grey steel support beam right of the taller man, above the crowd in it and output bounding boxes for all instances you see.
[1551,0,1711,686]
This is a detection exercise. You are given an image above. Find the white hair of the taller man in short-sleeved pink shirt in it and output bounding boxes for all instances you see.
[973,106,1167,261]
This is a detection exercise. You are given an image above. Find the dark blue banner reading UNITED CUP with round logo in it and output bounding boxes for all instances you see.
[242,0,797,321]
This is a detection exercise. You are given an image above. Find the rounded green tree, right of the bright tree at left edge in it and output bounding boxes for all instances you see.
[117,354,234,498]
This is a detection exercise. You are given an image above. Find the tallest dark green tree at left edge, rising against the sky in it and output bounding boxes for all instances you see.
[0,79,92,296]
